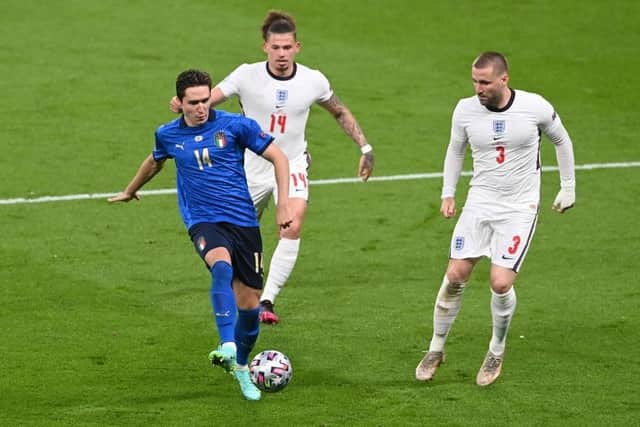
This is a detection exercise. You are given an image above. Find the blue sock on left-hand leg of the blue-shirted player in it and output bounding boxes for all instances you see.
[211,261,237,343]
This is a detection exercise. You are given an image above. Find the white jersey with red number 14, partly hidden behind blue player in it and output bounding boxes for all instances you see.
[218,61,333,180]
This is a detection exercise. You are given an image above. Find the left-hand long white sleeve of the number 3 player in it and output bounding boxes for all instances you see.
[441,102,468,199]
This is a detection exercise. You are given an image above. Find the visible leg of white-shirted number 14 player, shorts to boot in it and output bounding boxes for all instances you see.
[260,157,309,324]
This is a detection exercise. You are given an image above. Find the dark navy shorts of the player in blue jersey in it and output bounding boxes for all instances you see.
[189,222,263,289]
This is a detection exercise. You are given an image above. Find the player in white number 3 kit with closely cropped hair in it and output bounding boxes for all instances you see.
[416,52,575,386]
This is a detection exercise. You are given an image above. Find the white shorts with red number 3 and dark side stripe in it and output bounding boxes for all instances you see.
[449,203,538,273]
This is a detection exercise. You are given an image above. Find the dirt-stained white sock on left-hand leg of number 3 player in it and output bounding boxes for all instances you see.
[429,274,465,351]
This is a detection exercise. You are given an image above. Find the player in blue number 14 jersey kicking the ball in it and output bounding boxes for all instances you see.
[109,70,292,400]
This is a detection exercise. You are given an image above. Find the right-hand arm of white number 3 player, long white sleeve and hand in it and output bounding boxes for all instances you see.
[543,112,576,213]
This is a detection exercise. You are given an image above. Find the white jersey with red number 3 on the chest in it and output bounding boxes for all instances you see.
[442,89,571,206]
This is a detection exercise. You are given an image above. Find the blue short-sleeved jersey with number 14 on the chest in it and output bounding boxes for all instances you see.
[153,110,273,229]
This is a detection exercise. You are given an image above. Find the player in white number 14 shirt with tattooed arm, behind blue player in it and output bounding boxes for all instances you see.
[171,11,374,324]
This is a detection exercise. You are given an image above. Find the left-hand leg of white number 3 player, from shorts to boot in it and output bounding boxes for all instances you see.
[416,259,477,381]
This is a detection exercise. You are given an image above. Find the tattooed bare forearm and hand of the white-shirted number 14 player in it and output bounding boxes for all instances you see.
[319,93,375,181]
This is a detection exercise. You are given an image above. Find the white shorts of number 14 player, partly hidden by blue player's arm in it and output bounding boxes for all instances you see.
[247,154,309,217]
